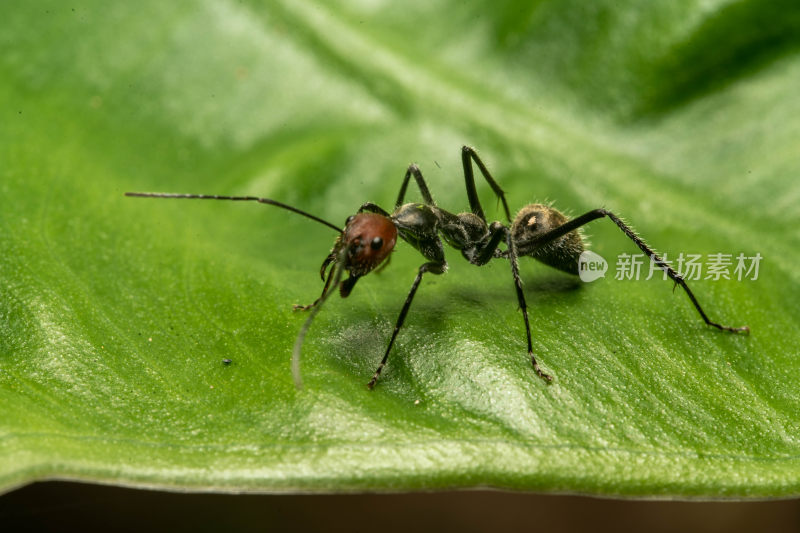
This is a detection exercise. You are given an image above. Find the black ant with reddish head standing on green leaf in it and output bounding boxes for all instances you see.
[125,146,750,389]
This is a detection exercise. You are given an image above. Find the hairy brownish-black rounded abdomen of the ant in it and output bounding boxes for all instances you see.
[511,204,583,275]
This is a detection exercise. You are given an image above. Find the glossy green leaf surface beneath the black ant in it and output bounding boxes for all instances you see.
[0,0,800,497]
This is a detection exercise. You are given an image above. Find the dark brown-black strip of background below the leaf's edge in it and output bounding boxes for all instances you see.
[0,482,800,533]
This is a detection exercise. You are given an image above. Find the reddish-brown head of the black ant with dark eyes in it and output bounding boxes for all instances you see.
[334,213,397,296]
